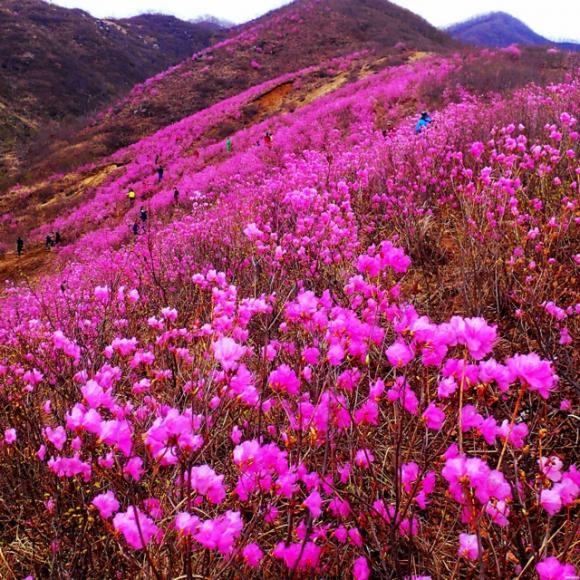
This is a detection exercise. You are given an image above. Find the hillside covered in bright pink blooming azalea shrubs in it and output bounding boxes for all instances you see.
[0,47,580,580]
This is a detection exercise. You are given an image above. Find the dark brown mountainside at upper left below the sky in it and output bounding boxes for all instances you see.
[0,0,223,177]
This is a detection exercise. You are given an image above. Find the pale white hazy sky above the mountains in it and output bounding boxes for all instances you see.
[53,0,580,40]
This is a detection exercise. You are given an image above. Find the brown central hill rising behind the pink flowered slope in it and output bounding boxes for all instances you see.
[14,0,455,179]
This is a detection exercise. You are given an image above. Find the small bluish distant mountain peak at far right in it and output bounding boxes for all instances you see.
[447,12,580,50]
